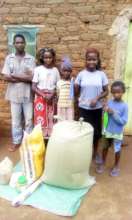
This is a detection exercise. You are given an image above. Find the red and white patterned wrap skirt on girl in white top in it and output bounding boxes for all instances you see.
[34,91,56,139]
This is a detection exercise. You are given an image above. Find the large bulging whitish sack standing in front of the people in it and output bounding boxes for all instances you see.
[44,121,95,189]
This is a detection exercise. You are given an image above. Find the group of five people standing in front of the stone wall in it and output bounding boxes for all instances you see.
[2,34,128,176]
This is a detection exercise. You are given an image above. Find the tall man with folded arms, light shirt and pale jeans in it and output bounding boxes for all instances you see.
[2,34,35,151]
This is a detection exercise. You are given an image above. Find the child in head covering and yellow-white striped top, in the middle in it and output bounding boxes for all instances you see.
[57,57,74,120]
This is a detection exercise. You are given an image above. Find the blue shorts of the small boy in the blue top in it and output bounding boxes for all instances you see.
[102,137,122,153]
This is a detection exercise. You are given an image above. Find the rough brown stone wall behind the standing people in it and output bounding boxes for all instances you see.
[0,0,132,135]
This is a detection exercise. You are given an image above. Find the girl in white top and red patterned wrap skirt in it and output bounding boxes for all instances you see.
[32,48,59,139]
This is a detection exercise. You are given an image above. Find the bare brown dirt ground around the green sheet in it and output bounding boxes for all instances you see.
[0,137,132,220]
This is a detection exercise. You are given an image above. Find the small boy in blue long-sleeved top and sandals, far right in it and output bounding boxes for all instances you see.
[96,81,128,176]
